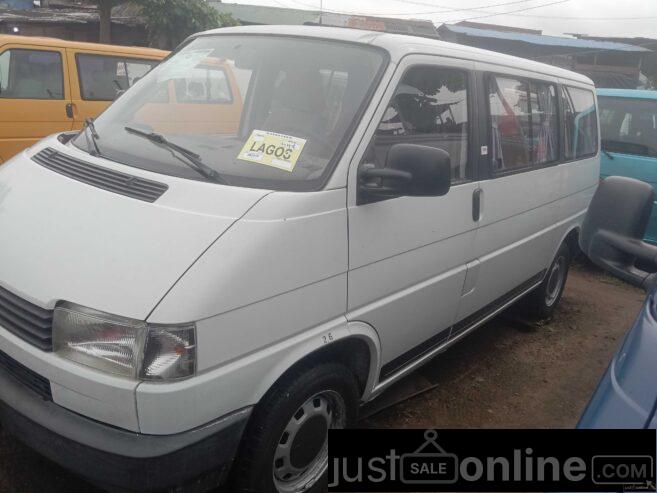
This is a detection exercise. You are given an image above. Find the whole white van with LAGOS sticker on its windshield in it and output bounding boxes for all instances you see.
[0,26,599,493]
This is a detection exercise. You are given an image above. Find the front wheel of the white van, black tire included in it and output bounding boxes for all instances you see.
[230,363,360,493]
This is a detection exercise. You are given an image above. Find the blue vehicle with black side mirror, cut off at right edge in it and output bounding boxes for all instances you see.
[578,177,657,429]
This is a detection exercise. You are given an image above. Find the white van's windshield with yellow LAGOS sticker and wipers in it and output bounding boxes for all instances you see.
[73,35,385,191]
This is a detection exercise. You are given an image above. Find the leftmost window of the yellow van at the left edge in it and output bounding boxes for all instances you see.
[0,49,64,99]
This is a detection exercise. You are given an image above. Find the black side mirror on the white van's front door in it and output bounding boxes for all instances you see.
[358,144,452,203]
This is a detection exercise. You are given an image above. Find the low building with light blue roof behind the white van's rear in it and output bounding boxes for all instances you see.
[438,22,657,89]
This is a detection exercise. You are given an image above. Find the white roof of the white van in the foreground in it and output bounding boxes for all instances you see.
[199,25,593,86]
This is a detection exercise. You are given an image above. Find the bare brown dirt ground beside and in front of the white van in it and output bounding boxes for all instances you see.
[0,265,644,493]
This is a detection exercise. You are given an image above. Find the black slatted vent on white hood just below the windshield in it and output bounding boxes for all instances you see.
[32,147,169,202]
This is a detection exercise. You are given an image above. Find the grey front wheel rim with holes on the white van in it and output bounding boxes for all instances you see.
[273,390,346,493]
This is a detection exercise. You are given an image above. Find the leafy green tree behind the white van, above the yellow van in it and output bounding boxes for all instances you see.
[134,0,237,50]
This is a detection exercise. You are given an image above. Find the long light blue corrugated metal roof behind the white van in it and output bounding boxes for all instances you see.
[442,24,651,52]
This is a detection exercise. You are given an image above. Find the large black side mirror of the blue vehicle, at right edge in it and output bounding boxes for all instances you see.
[579,176,657,289]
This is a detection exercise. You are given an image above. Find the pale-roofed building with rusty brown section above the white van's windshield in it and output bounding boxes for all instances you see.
[208,1,437,38]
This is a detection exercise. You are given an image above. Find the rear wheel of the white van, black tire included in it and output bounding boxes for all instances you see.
[526,243,571,319]
